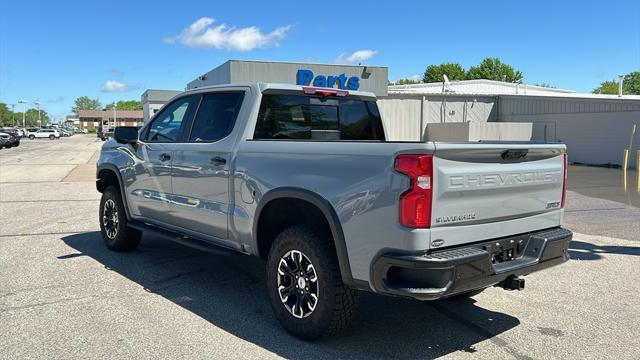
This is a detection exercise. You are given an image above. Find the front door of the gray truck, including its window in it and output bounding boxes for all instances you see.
[126,95,199,224]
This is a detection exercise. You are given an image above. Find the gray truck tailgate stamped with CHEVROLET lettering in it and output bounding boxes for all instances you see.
[431,143,565,246]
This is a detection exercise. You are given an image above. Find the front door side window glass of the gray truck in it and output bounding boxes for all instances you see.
[144,96,197,142]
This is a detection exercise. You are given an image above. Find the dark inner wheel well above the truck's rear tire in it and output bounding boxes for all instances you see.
[256,198,335,259]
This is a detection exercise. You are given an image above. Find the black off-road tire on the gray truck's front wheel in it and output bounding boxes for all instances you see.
[98,185,142,252]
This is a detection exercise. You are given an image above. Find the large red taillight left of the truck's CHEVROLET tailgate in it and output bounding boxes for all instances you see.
[395,154,433,228]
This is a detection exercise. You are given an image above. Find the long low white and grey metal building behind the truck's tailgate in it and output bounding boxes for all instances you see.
[378,80,640,165]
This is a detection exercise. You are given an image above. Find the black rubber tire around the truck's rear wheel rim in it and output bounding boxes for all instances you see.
[267,226,358,340]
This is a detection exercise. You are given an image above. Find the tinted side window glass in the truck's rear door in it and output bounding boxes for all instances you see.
[189,92,243,142]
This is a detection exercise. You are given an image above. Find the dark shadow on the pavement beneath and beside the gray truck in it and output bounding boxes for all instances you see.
[58,232,520,358]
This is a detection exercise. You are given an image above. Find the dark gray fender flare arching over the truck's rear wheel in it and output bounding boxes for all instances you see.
[252,187,360,288]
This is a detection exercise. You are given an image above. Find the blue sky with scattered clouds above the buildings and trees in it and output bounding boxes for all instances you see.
[0,0,640,119]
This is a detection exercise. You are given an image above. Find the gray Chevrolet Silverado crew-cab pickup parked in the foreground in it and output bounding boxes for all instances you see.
[96,83,572,339]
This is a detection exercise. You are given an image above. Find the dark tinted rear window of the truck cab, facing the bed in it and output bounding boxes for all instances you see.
[254,94,385,141]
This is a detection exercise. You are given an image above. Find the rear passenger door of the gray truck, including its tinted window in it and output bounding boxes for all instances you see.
[172,90,244,242]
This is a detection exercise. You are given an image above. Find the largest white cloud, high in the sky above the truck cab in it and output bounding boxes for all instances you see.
[164,17,291,51]
